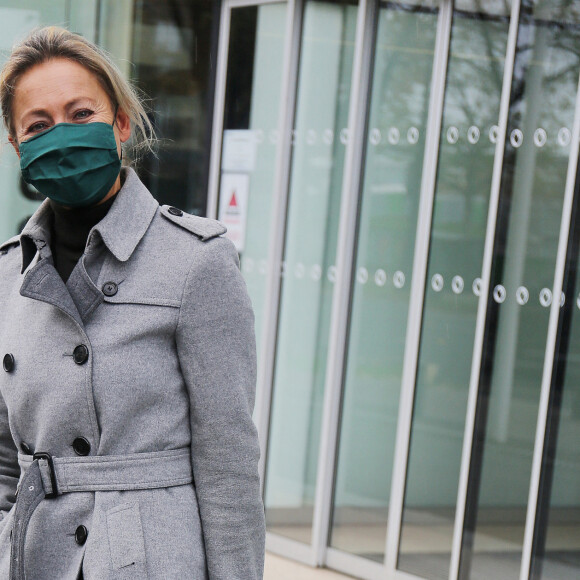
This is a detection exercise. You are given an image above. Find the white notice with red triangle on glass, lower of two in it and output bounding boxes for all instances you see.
[218,173,250,252]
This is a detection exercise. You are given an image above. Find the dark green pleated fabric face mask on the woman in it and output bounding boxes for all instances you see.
[20,123,121,207]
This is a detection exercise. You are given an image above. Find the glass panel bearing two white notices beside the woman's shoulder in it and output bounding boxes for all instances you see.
[218,3,286,353]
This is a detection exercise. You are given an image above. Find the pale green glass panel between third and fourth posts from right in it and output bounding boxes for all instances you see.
[330,1,437,561]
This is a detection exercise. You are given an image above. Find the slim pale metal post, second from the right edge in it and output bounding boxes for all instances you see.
[449,0,520,580]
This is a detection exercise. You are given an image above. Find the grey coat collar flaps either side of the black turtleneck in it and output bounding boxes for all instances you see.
[20,168,159,272]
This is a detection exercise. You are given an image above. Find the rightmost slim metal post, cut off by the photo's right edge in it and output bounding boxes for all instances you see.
[520,70,580,580]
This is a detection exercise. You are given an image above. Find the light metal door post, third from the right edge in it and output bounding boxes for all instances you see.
[385,0,453,576]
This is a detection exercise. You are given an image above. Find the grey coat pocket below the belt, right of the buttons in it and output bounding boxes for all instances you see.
[107,502,147,579]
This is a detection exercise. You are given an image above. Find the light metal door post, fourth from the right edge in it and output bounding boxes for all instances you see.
[312,0,377,566]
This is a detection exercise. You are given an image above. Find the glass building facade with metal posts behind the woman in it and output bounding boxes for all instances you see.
[0,0,580,580]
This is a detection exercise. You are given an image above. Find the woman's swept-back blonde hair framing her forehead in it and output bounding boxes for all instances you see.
[0,26,156,155]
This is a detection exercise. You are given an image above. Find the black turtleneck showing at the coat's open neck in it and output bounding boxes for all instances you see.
[49,194,117,282]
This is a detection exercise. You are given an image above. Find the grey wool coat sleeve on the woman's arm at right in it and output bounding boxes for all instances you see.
[177,238,265,580]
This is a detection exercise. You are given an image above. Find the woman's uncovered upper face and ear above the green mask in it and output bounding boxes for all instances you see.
[9,58,131,151]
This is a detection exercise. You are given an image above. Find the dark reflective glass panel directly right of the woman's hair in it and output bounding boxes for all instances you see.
[133,0,218,215]
